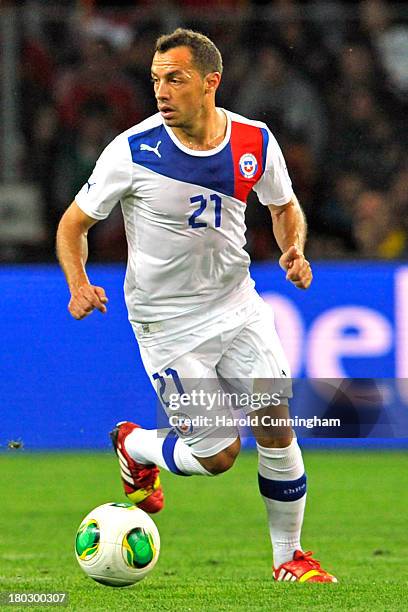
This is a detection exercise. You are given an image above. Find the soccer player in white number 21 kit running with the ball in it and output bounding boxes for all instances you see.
[57,28,336,582]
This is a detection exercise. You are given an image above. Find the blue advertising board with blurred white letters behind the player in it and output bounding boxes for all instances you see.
[0,263,408,449]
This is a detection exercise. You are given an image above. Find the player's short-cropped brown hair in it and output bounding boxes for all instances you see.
[155,28,222,76]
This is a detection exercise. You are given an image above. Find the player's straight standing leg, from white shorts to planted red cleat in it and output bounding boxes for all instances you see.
[217,299,335,582]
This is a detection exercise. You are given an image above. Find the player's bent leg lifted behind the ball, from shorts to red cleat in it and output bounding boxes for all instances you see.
[111,338,240,512]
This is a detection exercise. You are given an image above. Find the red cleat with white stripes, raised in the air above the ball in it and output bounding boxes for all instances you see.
[109,421,164,514]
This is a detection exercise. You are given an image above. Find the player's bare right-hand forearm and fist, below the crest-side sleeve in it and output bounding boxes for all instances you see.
[268,194,313,289]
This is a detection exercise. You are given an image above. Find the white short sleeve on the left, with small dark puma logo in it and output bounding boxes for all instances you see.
[75,136,132,221]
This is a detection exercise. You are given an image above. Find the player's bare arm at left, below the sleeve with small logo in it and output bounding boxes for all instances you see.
[57,200,108,319]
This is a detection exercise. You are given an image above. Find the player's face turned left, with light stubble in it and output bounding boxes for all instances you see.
[152,47,206,127]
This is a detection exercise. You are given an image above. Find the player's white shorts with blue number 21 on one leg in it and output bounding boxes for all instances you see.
[133,294,292,457]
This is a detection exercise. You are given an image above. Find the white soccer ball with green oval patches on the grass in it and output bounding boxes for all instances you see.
[75,503,160,587]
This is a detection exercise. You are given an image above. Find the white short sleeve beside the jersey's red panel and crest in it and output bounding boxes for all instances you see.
[253,129,293,206]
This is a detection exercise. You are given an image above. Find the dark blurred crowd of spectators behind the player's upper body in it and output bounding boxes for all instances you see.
[0,0,408,261]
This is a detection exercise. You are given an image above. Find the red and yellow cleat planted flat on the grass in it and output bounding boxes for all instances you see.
[273,550,337,582]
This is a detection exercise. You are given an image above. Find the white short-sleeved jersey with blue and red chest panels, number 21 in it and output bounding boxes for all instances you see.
[75,111,293,327]
